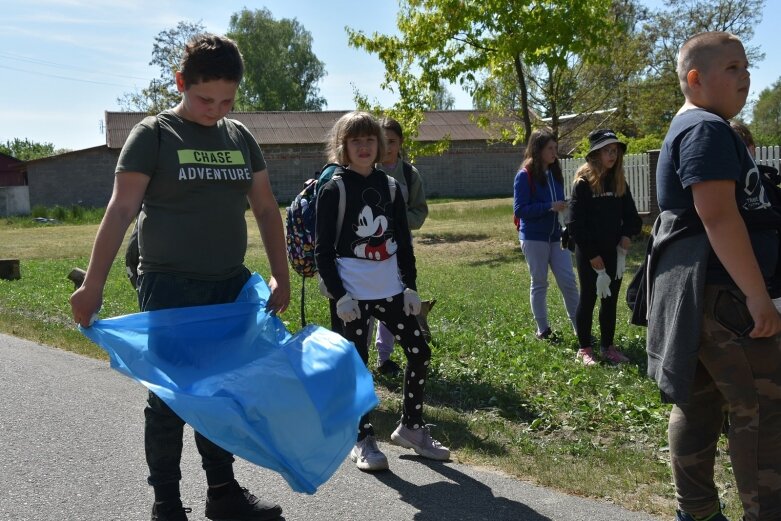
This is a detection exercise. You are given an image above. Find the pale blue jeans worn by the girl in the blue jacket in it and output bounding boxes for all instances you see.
[521,241,580,333]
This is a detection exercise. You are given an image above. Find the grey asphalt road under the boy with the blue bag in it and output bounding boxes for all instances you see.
[0,334,658,521]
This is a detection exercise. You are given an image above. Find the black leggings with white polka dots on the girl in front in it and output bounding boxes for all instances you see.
[343,293,431,440]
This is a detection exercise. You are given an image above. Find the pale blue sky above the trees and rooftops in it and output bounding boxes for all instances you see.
[0,0,781,150]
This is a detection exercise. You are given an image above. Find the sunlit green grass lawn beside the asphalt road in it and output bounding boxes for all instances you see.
[0,199,740,518]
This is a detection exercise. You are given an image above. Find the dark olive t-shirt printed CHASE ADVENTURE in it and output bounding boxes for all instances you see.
[116,111,266,280]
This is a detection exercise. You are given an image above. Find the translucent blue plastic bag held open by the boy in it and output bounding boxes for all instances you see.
[80,273,378,494]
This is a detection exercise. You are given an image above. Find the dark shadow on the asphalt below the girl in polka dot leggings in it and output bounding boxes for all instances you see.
[375,456,550,521]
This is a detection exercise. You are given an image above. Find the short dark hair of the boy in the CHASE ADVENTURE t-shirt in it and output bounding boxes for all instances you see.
[179,33,244,88]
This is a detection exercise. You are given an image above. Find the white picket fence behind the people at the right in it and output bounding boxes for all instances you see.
[561,146,781,213]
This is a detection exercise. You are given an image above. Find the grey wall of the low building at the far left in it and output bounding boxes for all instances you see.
[27,146,119,207]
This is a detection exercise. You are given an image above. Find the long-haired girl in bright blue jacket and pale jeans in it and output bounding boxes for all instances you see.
[513,129,579,339]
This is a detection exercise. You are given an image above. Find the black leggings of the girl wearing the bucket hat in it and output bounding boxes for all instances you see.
[575,249,621,349]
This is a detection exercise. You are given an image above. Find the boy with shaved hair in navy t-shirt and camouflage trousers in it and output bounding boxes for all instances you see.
[648,32,781,521]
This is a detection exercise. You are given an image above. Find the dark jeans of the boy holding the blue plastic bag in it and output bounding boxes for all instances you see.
[138,268,250,501]
